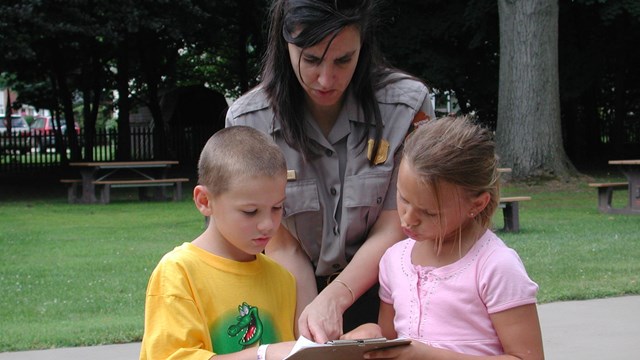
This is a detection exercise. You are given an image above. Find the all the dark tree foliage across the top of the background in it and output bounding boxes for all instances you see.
[0,0,640,174]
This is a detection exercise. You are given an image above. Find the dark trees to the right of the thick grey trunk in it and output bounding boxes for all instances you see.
[559,0,640,168]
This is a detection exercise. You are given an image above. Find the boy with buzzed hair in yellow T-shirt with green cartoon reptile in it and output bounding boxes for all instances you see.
[140,126,296,360]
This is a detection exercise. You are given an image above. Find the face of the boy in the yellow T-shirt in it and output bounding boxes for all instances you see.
[210,176,287,261]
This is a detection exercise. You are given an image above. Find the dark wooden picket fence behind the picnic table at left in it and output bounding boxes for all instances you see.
[0,128,204,173]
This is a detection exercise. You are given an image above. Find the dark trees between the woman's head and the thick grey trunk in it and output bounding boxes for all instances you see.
[380,0,499,124]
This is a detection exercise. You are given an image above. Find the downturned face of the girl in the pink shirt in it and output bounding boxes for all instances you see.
[397,160,474,242]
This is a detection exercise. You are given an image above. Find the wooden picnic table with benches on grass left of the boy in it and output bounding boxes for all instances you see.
[68,160,188,204]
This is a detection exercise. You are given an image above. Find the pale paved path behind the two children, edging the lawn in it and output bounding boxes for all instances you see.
[0,296,640,360]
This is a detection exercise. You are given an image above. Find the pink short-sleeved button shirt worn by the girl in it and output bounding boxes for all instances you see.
[380,230,538,355]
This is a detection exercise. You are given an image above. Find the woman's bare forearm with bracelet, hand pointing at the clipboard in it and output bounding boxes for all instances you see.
[298,210,405,343]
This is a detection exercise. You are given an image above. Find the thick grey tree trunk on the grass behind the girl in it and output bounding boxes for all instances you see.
[496,0,575,179]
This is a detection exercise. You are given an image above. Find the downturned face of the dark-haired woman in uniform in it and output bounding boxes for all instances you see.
[289,26,361,107]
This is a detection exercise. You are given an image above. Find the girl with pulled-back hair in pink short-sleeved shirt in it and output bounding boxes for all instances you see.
[344,117,544,359]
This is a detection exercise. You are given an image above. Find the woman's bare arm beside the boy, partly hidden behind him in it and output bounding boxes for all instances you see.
[265,225,318,338]
